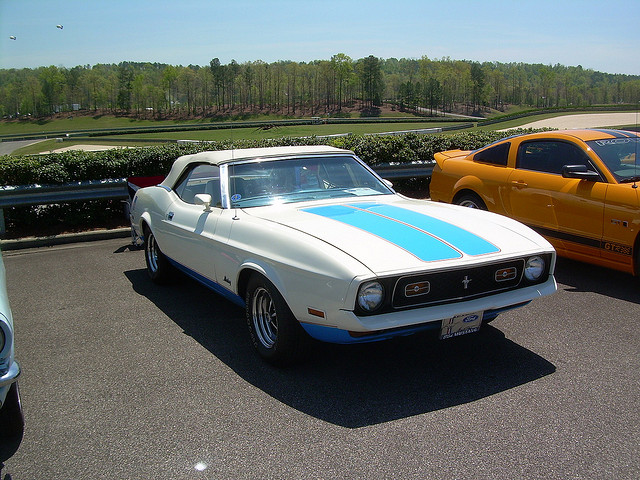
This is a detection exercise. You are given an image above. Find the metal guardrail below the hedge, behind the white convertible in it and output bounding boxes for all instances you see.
[0,163,434,235]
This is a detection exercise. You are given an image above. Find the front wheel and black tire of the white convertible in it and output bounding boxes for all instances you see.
[245,274,309,366]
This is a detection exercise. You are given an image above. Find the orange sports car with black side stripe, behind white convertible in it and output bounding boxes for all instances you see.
[430,129,640,275]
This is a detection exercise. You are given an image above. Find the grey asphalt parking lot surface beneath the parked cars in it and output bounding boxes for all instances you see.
[0,239,640,480]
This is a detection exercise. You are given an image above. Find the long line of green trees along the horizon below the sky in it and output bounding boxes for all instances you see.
[0,53,640,118]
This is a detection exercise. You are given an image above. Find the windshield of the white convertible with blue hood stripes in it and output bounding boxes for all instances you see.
[229,155,393,207]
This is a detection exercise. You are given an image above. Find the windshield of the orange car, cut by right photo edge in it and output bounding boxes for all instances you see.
[587,137,640,183]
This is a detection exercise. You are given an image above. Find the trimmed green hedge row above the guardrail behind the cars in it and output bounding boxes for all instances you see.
[0,130,544,185]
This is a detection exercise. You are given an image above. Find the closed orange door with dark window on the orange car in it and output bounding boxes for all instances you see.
[508,140,609,256]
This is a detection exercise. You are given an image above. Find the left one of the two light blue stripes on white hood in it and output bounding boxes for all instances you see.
[303,205,462,262]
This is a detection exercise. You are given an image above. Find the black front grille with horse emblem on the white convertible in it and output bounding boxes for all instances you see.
[391,259,524,309]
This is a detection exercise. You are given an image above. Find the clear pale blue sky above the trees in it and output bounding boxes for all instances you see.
[0,0,640,75]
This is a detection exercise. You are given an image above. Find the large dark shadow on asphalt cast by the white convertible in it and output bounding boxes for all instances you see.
[125,270,555,428]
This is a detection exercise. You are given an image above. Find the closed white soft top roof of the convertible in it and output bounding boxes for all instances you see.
[160,145,353,188]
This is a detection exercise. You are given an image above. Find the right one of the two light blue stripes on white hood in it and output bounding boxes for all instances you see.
[350,204,500,255]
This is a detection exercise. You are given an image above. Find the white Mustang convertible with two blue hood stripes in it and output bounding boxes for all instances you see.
[131,146,556,364]
